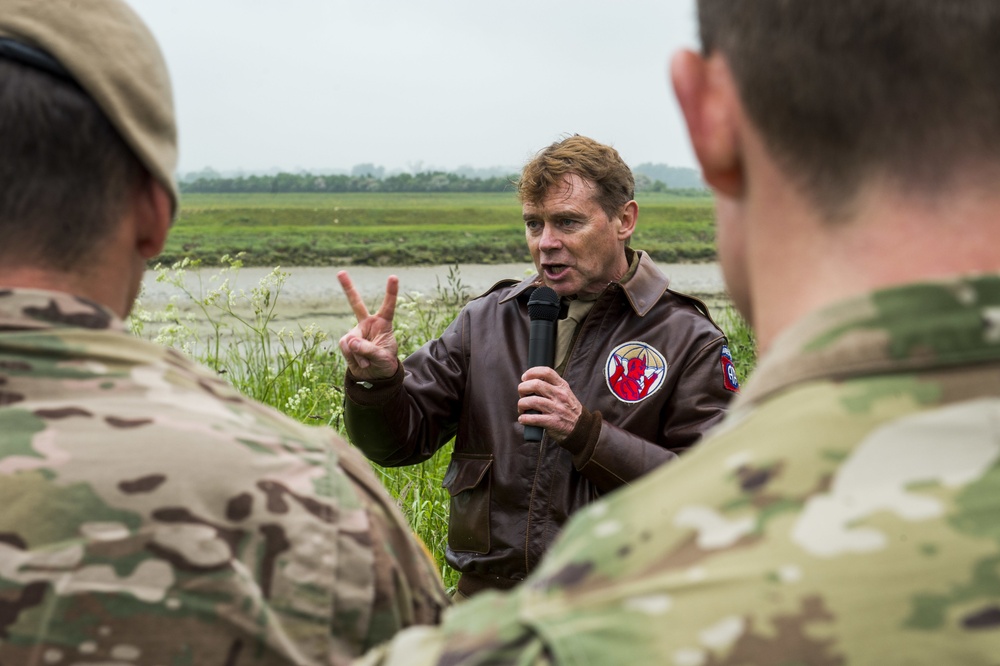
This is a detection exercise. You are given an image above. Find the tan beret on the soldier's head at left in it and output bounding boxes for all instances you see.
[0,0,178,213]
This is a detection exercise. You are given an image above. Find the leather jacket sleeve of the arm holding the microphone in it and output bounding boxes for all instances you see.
[562,336,734,493]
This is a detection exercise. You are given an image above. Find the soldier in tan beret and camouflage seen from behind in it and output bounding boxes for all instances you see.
[0,0,444,666]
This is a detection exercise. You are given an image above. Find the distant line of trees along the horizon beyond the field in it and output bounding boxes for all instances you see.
[180,171,705,196]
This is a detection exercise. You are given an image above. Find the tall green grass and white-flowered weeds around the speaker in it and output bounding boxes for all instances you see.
[129,255,756,590]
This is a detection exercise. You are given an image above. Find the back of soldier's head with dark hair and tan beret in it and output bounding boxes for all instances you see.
[0,0,177,271]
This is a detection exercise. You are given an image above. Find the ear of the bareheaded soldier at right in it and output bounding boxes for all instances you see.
[670,50,744,197]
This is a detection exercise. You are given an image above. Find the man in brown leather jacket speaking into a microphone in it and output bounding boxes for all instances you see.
[339,136,738,596]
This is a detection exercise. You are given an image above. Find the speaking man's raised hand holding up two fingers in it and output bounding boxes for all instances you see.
[337,271,399,379]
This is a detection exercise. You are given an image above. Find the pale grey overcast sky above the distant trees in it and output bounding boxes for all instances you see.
[129,0,697,173]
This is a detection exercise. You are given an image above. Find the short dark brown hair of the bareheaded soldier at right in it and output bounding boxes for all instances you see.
[698,0,1000,217]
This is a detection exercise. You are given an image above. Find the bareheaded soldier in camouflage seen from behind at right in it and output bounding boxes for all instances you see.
[369,0,1000,666]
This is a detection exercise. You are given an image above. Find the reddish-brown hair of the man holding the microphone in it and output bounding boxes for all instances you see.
[517,134,635,218]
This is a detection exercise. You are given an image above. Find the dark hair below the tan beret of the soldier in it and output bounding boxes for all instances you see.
[0,59,147,271]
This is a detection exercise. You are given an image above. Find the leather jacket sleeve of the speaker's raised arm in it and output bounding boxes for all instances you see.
[344,312,468,467]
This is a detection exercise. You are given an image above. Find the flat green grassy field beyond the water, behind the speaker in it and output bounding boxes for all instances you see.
[166,192,715,266]
